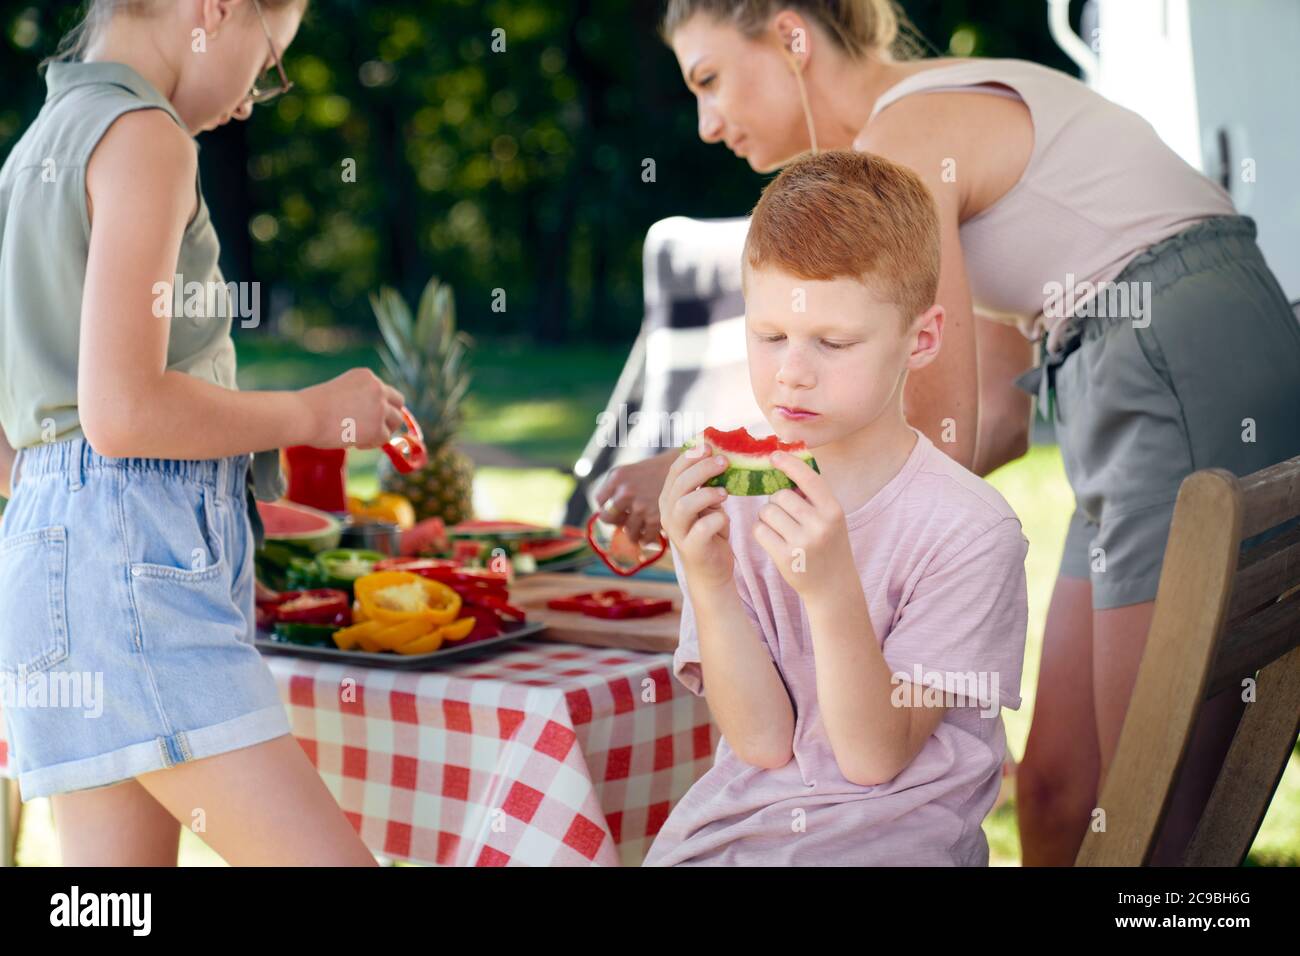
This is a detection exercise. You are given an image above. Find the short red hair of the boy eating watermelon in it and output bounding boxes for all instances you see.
[744,150,939,326]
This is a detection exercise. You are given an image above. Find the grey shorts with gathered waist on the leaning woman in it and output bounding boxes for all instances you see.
[1021,216,1300,609]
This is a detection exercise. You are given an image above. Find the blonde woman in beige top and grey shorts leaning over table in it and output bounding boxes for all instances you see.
[598,0,1300,865]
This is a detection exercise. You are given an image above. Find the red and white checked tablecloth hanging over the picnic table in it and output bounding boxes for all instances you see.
[0,640,720,866]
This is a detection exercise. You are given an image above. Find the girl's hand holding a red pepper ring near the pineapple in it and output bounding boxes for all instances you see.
[298,368,406,449]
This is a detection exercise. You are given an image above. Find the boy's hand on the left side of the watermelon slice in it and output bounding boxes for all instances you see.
[659,445,736,587]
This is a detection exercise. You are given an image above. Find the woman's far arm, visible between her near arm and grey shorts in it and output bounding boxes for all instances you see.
[971,316,1034,475]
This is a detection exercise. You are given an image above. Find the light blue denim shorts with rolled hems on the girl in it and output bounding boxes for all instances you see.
[0,437,290,800]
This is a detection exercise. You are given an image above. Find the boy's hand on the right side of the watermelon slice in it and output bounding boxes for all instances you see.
[754,451,861,601]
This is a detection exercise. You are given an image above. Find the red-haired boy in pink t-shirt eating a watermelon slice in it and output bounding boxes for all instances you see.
[645,152,1028,866]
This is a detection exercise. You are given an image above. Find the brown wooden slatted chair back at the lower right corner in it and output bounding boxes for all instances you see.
[1075,457,1300,866]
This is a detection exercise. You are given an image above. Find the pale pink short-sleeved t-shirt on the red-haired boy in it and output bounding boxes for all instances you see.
[644,429,1028,866]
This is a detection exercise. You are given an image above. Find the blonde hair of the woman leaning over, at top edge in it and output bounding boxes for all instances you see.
[659,0,926,60]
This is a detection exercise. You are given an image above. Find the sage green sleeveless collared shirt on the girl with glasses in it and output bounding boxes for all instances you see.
[0,62,285,530]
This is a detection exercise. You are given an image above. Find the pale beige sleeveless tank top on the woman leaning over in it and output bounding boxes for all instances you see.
[871,59,1236,350]
